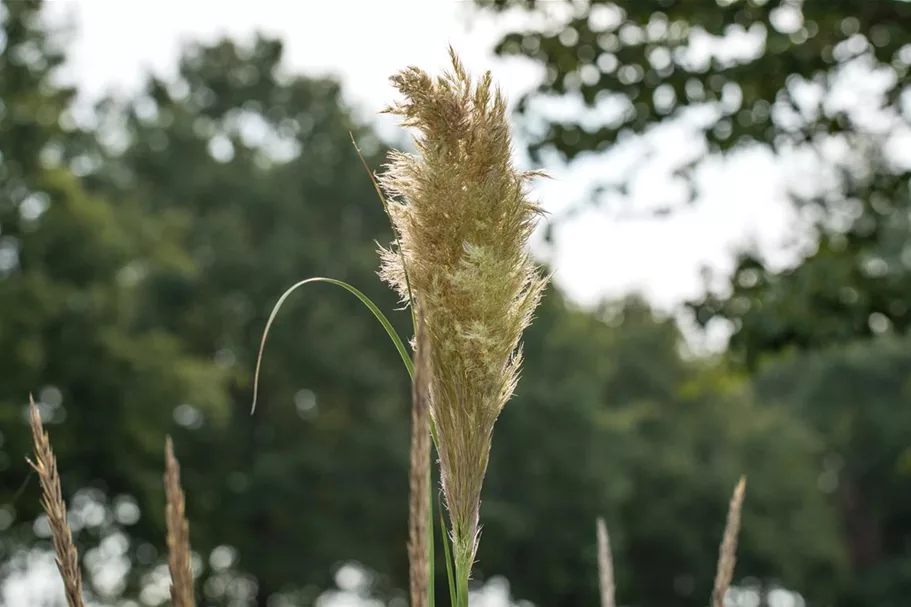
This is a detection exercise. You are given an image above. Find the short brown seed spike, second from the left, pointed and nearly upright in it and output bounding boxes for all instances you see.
[164,436,195,607]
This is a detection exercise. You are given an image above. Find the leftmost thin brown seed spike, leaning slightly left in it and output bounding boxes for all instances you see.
[27,395,85,607]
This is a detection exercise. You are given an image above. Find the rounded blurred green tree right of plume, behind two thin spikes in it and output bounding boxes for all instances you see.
[479,293,844,607]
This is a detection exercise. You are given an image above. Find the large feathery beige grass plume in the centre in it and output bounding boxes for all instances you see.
[380,49,547,584]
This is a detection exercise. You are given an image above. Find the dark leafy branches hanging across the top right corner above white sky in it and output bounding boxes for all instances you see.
[476,0,911,164]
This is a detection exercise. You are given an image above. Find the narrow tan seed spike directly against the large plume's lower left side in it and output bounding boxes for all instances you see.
[408,312,430,607]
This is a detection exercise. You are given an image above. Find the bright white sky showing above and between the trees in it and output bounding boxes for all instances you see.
[48,0,793,338]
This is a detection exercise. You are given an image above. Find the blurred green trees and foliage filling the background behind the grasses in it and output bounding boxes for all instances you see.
[0,0,911,607]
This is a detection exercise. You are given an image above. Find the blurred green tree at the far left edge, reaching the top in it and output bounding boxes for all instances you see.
[0,0,225,600]
